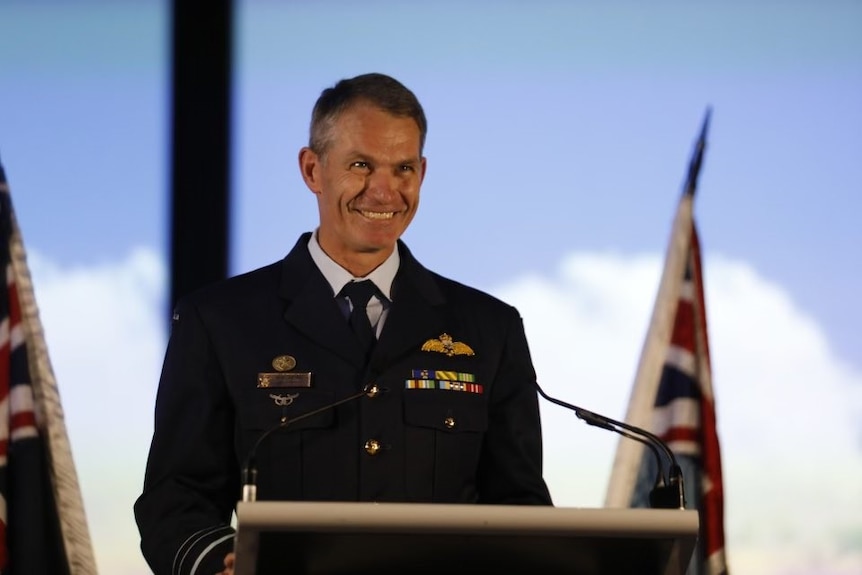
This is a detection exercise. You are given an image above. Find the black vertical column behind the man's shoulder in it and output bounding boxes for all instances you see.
[168,0,233,316]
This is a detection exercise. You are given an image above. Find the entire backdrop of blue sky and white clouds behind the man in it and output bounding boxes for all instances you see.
[0,0,862,575]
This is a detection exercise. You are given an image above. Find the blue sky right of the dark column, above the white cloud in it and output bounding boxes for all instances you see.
[234,1,862,366]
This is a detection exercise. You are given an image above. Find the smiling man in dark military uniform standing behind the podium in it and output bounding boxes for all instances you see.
[135,74,551,574]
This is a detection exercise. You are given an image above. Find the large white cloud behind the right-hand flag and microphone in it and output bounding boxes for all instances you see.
[495,254,862,575]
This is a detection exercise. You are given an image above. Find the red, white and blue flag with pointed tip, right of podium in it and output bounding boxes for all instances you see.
[605,111,728,575]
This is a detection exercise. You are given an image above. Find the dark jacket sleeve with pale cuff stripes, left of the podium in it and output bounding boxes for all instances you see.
[134,303,239,575]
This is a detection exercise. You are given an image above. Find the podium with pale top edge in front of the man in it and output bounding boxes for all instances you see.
[234,501,698,575]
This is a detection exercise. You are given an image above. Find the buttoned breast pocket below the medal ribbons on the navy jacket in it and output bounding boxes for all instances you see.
[404,389,488,502]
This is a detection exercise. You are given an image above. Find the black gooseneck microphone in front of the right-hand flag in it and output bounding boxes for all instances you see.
[534,382,685,509]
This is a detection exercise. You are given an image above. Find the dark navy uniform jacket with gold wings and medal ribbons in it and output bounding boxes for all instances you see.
[135,234,551,574]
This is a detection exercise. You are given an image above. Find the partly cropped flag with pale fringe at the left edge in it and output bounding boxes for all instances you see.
[0,165,96,575]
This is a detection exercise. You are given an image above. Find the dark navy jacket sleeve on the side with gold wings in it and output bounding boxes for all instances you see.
[478,308,552,505]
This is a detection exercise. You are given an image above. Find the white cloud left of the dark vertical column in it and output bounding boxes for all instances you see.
[29,250,169,575]
